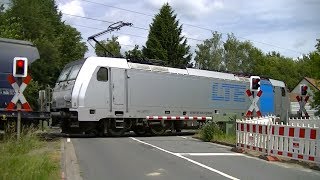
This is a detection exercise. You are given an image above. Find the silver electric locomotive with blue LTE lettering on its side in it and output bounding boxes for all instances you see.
[52,57,289,136]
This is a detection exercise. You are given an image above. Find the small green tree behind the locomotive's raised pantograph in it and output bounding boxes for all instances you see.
[95,36,121,57]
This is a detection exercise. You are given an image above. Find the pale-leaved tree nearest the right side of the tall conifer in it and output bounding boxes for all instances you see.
[195,32,224,71]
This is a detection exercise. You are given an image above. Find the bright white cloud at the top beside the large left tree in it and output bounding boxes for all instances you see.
[58,0,85,16]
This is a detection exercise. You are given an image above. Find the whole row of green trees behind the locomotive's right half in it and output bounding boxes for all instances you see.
[195,32,320,90]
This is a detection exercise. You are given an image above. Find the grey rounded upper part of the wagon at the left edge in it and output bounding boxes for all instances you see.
[0,38,40,72]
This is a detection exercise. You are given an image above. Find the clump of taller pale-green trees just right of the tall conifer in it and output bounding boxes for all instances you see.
[195,32,263,73]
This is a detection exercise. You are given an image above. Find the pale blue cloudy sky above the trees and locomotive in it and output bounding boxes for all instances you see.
[56,0,320,58]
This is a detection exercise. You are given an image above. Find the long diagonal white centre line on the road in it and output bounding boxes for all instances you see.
[130,137,239,180]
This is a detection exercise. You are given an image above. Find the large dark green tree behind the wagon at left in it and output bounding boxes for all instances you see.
[0,0,87,109]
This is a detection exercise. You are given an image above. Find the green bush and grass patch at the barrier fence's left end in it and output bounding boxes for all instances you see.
[198,122,236,144]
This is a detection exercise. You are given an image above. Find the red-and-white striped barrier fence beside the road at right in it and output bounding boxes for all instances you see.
[236,116,320,164]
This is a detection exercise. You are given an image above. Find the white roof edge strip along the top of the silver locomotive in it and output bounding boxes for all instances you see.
[81,57,285,87]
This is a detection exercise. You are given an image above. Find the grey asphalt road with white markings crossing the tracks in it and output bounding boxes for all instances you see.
[71,136,320,180]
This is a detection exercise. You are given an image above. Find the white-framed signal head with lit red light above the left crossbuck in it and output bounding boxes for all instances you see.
[13,57,28,77]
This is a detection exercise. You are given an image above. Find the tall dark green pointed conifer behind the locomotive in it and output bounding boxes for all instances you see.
[142,3,191,68]
